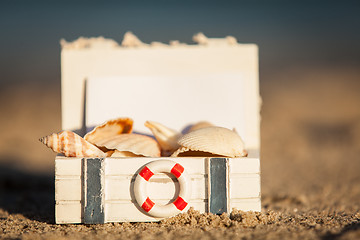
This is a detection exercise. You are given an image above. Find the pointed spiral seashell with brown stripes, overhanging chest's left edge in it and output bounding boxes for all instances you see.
[39,131,105,157]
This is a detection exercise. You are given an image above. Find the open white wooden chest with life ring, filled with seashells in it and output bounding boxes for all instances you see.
[50,33,261,224]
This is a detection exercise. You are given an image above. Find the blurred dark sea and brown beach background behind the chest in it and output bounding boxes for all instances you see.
[0,0,360,218]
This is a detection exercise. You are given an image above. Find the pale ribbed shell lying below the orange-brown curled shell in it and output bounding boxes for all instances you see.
[92,133,160,157]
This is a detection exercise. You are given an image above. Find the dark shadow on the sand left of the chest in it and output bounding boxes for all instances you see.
[0,158,55,223]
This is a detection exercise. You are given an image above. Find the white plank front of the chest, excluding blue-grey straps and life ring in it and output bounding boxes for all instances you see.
[55,156,261,223]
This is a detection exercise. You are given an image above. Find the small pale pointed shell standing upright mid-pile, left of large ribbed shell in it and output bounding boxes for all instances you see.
[145,121,182,156]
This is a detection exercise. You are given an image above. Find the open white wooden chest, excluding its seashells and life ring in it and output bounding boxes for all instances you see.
[55,33,261,223]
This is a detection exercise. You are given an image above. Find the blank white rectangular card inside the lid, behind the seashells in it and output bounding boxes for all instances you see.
[86,73,249,142]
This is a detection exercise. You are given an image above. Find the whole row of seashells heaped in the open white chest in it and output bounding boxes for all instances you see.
[40,118,247,157]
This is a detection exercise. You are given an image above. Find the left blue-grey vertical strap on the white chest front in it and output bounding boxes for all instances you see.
[83,158,105,224]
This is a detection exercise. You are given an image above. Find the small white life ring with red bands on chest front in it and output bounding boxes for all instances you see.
[134,160,191,217]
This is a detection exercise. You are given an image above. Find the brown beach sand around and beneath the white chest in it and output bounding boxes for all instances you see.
[0,67,360,239]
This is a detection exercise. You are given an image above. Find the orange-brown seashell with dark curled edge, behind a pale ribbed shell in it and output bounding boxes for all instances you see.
[84,118,134,145]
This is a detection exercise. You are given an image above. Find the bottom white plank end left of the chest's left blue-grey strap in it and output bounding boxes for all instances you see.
[55,201,82,224]
